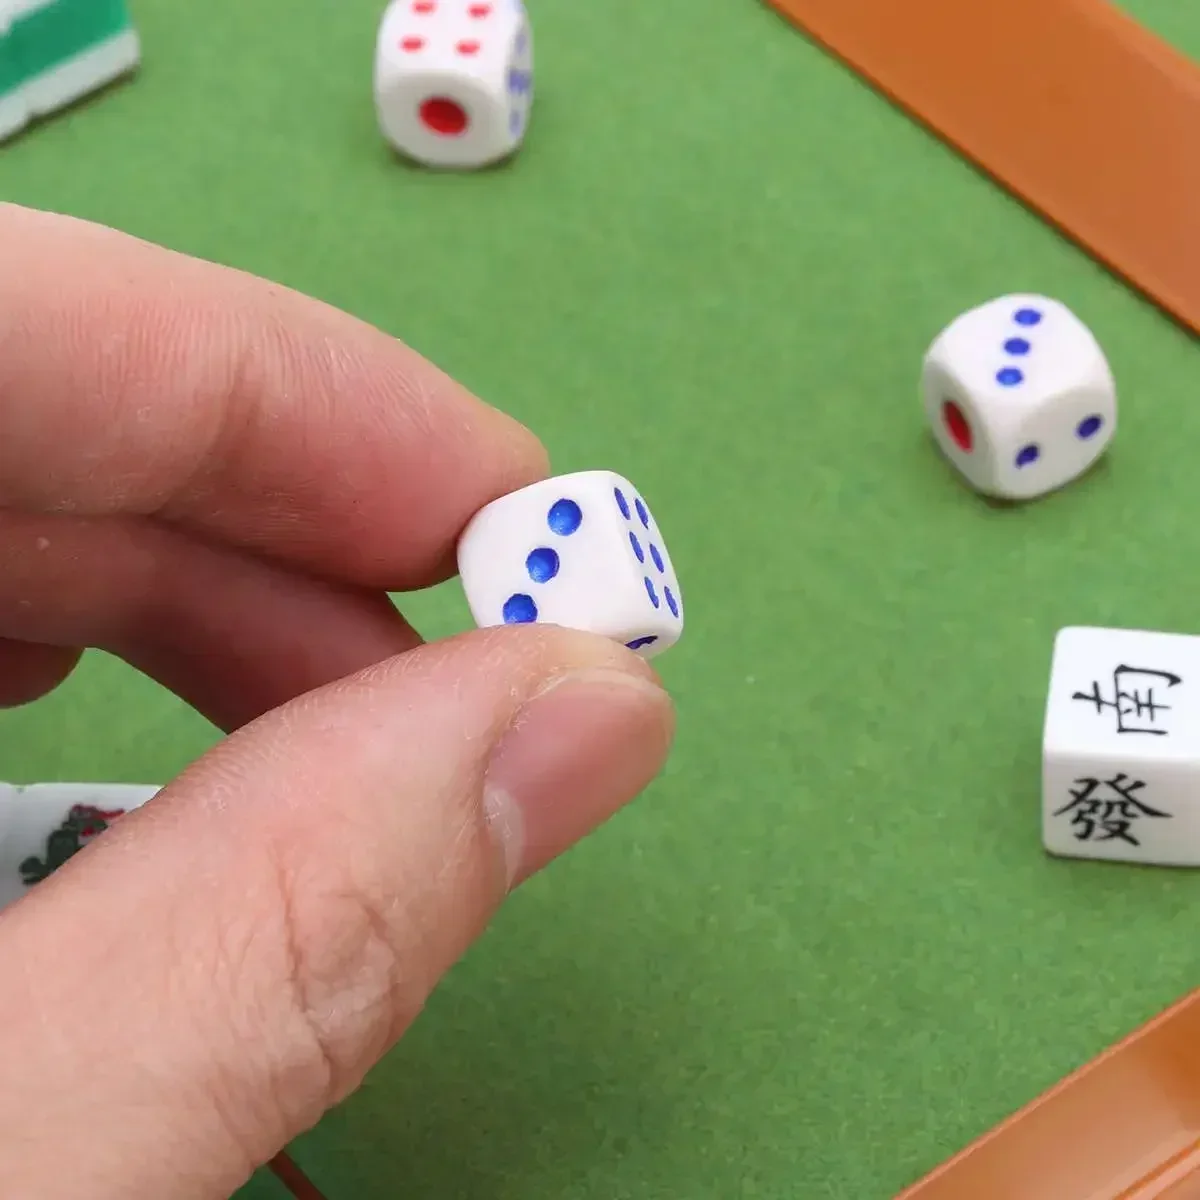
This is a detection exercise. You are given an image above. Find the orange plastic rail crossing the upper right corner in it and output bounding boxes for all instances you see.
[768,0,1200,332]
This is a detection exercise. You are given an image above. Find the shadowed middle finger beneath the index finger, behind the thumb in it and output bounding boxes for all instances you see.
[0,510,421,730]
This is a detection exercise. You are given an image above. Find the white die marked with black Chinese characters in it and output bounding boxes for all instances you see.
[1042,626,1200,866]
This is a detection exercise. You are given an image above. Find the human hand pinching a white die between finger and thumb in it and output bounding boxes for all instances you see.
[0,205,672,1200]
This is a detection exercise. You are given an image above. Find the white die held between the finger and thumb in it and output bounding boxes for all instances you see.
[458,470,683,658]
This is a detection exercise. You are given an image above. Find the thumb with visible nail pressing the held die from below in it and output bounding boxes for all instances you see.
[0,626,672,1200]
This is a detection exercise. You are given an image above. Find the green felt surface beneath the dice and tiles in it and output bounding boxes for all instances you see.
[0,0,1200,1200]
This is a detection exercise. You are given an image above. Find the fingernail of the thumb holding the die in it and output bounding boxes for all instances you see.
[484,670,673,887]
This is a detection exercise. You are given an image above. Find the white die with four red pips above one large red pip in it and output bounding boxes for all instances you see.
[374,0,533,168]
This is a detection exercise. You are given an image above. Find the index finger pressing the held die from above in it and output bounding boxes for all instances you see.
[0,204,547,589]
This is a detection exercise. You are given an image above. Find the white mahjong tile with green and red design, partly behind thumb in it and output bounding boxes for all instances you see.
[0,784,158,908]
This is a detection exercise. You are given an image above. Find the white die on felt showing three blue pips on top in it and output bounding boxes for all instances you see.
[920,295,1117,500]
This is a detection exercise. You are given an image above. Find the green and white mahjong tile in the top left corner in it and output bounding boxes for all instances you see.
[0,0,142,140]
